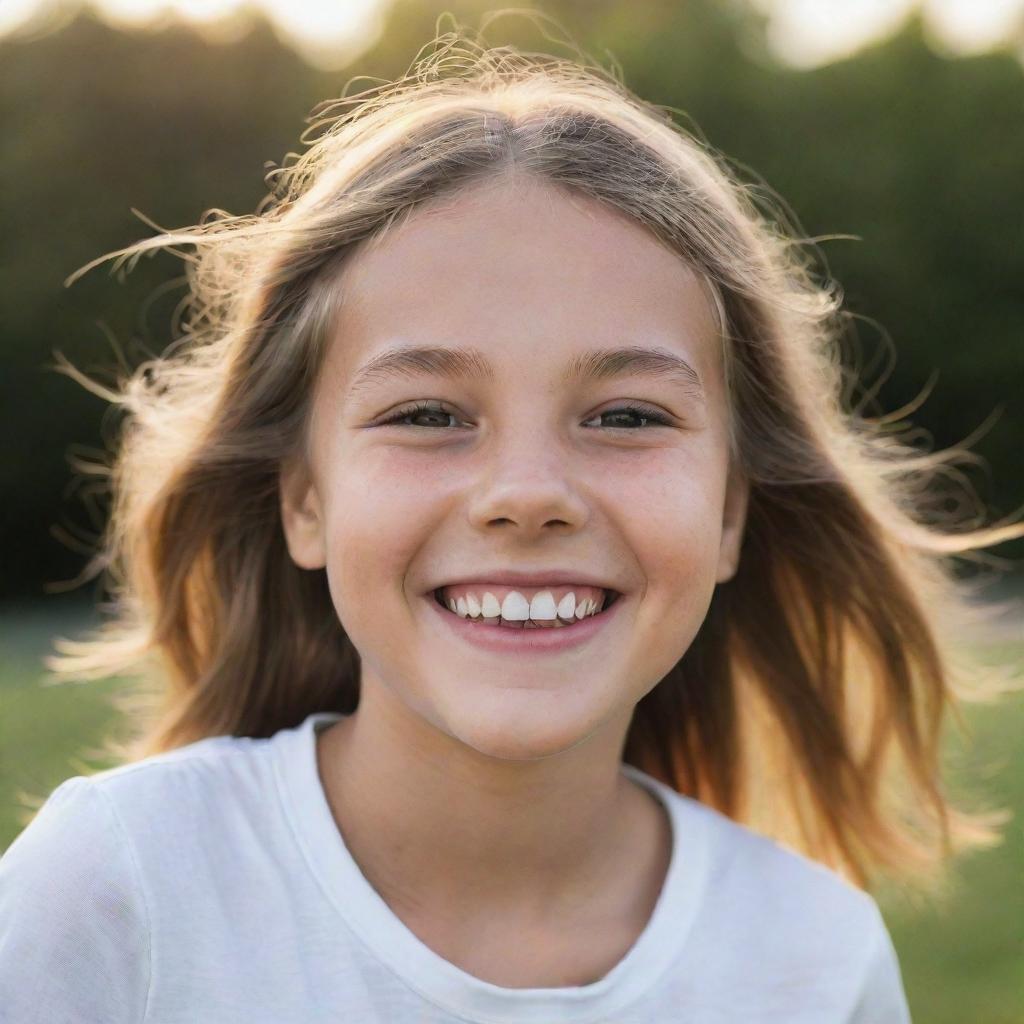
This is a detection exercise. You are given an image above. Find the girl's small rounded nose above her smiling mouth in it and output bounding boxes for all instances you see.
[469,421,588,534]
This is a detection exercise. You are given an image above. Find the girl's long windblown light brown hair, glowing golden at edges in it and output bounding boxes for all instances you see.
[39,12,1024,890]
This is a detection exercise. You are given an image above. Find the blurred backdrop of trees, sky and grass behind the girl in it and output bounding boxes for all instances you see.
[0,0,1024,1024]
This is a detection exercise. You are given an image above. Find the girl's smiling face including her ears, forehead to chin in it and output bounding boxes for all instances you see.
[282,181,748,759]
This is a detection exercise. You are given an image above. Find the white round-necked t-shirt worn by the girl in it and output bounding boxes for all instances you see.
[0,712,910,1024]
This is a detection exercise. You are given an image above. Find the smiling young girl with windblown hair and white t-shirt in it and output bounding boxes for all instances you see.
[0,18,1024,1024]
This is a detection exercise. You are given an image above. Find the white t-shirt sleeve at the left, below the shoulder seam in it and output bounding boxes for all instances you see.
[0,775,151,1024]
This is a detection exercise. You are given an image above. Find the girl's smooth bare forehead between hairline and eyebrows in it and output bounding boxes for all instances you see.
[330,181,721,391]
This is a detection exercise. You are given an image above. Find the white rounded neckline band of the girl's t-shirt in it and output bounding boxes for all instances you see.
[272,712,711,1024]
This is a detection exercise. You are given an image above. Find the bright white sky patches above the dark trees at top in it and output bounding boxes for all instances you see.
[0,0,1024,71]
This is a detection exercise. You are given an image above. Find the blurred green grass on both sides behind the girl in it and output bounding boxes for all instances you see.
[0,601,1024,1024]
